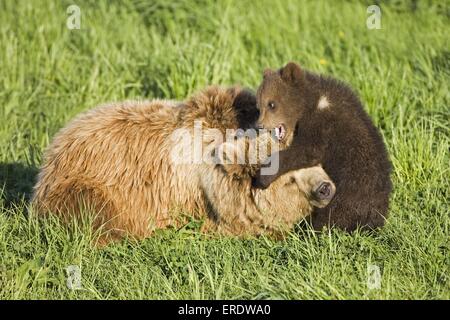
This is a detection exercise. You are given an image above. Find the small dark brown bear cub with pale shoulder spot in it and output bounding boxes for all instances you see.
[254,62,392,231]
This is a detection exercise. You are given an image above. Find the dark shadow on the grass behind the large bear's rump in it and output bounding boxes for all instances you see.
[0,163,38,208]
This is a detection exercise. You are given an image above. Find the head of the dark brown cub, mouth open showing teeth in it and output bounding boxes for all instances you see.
[256,62,314,145]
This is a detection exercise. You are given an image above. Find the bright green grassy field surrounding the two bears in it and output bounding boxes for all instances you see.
[0,0,450,299]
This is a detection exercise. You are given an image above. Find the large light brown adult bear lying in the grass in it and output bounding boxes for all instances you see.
[32,87,334,244]
